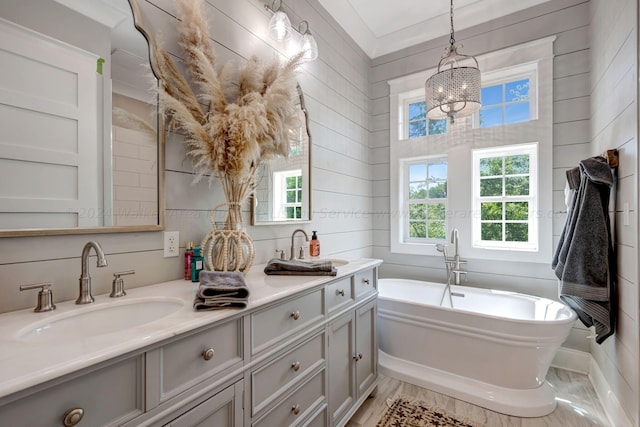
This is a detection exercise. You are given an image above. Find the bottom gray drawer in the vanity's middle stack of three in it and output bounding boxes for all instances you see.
[253,370,326,427]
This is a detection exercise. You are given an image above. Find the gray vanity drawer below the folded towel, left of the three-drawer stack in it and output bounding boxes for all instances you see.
[154,318,243,403]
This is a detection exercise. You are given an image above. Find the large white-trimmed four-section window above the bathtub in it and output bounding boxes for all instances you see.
[388,37,555,263]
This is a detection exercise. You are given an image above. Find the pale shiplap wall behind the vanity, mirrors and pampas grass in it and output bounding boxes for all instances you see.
[0,0,371,313]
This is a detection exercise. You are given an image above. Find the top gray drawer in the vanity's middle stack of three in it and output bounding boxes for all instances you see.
[251,288,324,355]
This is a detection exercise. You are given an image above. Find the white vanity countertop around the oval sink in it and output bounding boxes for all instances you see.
[0,258,382,397]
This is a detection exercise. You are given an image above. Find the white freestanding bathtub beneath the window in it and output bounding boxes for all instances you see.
[378,279,577,417]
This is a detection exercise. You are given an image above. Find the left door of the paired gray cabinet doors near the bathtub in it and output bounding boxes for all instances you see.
[328,312,356,425]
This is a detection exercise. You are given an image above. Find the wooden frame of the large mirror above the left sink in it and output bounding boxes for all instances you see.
[0,0,165,237]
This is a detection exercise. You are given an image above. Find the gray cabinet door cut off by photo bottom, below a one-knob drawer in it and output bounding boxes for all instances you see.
[165,381,243,427]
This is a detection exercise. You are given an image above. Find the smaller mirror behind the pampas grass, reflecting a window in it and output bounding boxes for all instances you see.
[252,85,311,225]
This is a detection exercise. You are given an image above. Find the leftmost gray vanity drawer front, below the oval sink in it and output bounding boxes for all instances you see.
[0,356,144,427]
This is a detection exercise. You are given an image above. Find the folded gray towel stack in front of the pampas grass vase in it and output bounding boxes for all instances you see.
[193,271,249,310]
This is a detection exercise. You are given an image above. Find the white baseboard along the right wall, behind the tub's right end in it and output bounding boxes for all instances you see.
[551,347,633,427]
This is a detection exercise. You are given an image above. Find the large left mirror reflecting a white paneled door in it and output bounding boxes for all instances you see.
[0,0,164,236]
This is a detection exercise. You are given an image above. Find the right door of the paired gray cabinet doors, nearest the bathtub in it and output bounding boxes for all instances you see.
[355,300,378,398]
